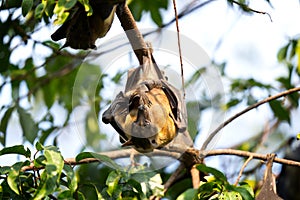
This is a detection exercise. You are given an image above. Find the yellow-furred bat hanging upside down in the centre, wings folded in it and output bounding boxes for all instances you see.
[102,46,192,153]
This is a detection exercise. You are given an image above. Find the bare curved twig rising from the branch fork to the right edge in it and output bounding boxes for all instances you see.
[201,87,300,150]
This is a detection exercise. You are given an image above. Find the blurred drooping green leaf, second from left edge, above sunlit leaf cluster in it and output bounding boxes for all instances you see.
[17,106,39,144]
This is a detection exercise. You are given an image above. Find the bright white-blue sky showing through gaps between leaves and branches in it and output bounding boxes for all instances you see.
[0,0,300,170]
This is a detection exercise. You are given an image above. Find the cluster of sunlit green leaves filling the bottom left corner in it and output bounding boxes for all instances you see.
[0,143,163,199]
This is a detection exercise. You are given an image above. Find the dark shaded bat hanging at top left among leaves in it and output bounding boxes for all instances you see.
[51,0,117,49]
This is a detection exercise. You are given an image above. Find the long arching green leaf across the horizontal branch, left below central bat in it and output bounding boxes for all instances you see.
[76,152,122,170]
